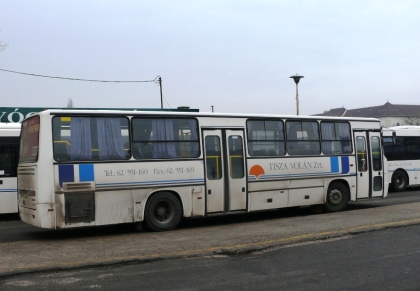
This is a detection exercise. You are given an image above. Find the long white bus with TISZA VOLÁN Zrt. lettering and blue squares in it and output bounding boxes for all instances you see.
[18,110,388,231]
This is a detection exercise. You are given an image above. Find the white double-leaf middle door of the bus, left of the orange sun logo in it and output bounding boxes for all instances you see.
[203,129,247,213]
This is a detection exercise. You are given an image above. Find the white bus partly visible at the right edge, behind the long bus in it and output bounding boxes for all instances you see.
[383,126,420,192]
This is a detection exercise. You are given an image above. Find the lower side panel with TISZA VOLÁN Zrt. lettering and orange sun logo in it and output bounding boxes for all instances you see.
[248,156,356,211]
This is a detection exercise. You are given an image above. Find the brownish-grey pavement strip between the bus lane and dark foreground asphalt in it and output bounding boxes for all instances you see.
[0,203,420,278]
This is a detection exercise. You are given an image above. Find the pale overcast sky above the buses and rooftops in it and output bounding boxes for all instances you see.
[0,0,420,115]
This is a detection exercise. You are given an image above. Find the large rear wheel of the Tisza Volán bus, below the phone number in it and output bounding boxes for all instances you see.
[144,192,182,231]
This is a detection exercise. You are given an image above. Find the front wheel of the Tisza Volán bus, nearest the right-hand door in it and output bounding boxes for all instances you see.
[323,182,350,212]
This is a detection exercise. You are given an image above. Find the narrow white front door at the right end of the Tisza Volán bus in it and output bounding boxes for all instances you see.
[354,131,384,199]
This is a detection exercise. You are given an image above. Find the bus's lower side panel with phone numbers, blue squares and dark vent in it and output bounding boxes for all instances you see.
[54,161,205,228]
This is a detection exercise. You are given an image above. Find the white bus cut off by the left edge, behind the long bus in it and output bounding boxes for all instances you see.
[0,123,20,214]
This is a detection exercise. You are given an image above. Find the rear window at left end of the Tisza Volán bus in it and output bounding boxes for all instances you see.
[19,116,39,163]
